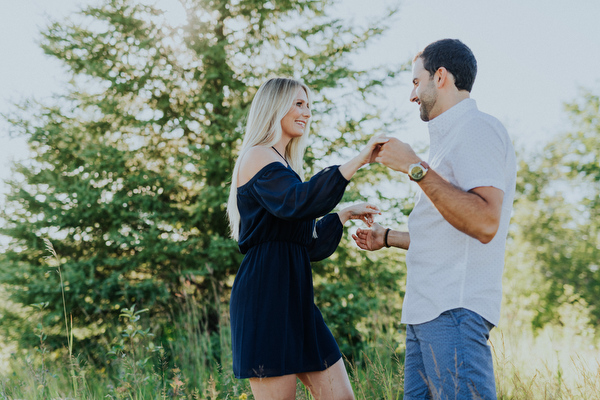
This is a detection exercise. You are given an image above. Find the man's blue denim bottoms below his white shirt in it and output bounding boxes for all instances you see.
[404,308,496,400]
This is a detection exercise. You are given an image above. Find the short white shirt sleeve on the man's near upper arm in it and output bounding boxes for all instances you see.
[450,119,508,191]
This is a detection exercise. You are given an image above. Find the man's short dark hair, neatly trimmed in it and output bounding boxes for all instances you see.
[415,39,477,92]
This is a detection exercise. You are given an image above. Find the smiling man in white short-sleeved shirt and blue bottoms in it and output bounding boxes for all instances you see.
[353,39,516,400]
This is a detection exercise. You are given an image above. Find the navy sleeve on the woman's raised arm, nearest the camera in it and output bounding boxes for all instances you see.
[253,163,348,221]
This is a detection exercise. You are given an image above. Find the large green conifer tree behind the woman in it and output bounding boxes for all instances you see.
[0,0,402,364]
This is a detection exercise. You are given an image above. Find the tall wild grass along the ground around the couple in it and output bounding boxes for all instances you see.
[0,302,600,399]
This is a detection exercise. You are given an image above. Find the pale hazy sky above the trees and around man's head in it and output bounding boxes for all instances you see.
[0,0,600,197]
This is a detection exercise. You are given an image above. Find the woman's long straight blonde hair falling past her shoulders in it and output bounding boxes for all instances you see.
[227,78,311,240]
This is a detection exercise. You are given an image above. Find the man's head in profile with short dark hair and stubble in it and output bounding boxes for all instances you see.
[410,39,477,121]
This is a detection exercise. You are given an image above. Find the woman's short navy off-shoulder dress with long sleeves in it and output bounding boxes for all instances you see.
[230,162,348,379]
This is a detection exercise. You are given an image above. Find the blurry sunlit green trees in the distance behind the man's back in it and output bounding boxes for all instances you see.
[515,93,600,326]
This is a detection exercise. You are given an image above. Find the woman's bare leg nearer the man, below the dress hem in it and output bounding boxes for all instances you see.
[298,358,354,400]
